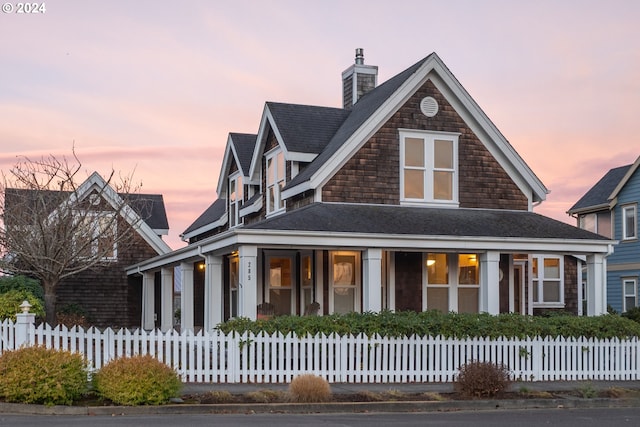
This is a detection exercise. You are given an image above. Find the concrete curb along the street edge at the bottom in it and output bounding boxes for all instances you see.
[0,398,640,416]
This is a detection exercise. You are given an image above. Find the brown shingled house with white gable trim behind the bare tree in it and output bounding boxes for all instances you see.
[5,172,171,327]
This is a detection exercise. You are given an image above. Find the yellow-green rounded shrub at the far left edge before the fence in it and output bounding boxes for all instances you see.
[0,347,88,405]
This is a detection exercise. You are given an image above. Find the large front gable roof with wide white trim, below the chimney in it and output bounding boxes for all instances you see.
[282,53,548,206]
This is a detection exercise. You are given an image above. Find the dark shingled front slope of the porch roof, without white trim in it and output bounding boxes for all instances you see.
[244,203,610,241]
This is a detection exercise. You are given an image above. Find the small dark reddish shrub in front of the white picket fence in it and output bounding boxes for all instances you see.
[454,361,510,398]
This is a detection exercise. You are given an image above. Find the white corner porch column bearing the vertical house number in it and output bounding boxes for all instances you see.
[238,245,258,320]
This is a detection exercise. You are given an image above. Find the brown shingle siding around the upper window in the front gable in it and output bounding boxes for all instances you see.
[322,81,528,210]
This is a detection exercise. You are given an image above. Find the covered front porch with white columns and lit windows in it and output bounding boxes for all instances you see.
[128,229,608,331]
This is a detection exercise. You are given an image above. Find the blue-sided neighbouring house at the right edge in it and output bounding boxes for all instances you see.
[567,157,640,312]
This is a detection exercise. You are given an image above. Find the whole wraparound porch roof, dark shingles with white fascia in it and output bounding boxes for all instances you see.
[126,203,616,274]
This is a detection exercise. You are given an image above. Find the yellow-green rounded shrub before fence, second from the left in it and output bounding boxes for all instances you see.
[94,356,182,405]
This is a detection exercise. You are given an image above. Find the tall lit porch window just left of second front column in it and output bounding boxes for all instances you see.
[329,251,361,314]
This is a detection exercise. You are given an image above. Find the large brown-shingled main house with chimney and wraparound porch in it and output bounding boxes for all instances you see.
[127,49,612,330]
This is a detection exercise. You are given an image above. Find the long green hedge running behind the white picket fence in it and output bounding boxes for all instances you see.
[217,310,640,339]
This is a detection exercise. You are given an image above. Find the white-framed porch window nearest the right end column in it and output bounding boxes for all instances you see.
[531,255,564,308]
